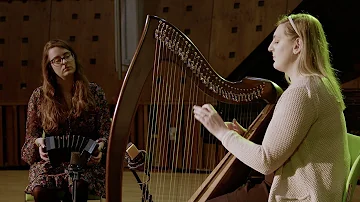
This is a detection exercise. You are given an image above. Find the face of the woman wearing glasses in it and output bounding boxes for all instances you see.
[48,47,76,80]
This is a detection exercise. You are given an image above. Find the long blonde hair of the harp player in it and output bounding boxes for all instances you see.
[276,13,345,110]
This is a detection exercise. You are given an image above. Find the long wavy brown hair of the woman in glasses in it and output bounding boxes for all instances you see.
[41,39,94,132]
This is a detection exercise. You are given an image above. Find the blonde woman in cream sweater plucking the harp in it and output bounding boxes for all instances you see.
[194,13,350,202]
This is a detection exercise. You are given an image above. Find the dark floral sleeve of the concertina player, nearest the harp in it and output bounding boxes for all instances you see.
[95,86,111,152]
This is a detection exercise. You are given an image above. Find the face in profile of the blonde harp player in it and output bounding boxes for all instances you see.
[268,24,294,72]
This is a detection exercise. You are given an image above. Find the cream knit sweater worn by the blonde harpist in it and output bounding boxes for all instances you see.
[216,77,350,202]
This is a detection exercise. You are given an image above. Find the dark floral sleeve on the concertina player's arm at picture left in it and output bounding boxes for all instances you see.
[21,88,42,165]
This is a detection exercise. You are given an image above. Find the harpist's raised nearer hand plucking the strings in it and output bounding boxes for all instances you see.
[193,104,229,140]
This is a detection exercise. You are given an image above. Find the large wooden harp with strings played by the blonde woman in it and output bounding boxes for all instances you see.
[106,16,282,202]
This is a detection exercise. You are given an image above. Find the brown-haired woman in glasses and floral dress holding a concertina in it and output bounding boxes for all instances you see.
[21,40,110,202]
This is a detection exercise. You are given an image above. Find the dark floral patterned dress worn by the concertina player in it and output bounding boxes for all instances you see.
[21,83,111,196]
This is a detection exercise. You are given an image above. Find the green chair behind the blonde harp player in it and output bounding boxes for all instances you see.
[342,133,360,202]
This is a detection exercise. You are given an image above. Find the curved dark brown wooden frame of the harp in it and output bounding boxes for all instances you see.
[106,15,282,202]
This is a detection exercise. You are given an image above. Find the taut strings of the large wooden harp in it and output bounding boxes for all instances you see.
[142,22,264,201]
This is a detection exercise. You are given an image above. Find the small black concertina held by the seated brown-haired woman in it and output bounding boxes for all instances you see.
[45,135,98,167]
